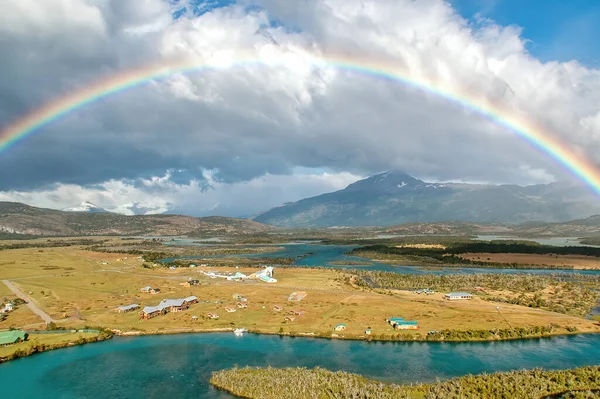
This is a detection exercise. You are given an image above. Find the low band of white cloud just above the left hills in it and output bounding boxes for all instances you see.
[0,171,360,216]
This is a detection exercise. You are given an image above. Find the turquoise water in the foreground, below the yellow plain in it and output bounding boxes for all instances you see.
[0,333,600,399]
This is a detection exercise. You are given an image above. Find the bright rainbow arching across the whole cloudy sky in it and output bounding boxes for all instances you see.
[0,52,600,194]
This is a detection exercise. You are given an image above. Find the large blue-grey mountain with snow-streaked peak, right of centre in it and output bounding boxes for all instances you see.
[254,172,600,227]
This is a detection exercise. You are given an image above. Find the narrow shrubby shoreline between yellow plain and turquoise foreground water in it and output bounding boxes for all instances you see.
[0,327,600,365]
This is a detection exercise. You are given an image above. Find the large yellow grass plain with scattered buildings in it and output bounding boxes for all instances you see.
[0,247,600,337]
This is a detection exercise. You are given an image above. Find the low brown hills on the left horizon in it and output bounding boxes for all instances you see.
[0,202,274,236]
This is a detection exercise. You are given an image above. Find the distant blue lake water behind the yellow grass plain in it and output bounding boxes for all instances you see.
[162,241,600,274]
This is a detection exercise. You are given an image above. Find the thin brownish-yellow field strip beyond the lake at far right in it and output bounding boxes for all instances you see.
[458,253,600,270]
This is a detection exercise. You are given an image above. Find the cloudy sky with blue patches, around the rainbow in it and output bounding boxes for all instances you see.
[0,0,600,216]
